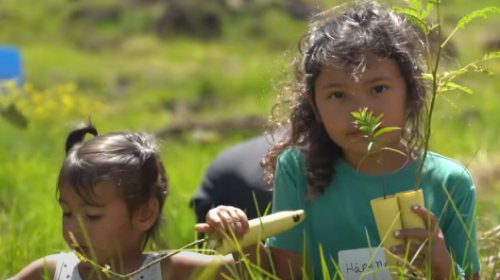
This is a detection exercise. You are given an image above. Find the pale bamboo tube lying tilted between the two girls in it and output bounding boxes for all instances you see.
[217,210,305,255]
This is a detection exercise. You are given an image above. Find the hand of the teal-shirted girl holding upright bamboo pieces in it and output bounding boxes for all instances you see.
[391,205,452,279]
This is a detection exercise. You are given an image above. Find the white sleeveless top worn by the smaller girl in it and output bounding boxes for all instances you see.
[54,252,162,280]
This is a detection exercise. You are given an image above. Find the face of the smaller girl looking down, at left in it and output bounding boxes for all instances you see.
[59,183,143,265]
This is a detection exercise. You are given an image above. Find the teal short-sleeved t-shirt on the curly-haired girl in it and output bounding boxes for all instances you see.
[267,149,479,277]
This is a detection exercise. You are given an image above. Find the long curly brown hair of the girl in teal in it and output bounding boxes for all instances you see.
[261,2,426,195]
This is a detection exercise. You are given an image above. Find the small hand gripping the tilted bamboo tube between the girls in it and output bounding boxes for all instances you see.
[195,206,249,238]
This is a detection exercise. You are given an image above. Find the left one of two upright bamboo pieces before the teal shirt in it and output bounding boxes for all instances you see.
[370,196,403,266]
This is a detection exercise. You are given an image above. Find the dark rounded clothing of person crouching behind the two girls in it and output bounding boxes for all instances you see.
[191,136,272,223]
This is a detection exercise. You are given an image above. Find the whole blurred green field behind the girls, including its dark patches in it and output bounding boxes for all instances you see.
[0,0,500,279]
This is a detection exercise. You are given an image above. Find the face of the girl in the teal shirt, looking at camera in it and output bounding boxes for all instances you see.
[315,55,406,163]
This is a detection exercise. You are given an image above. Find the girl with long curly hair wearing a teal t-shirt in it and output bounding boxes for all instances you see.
[198,2,479,279]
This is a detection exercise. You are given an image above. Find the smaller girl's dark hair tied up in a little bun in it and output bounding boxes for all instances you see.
[57,124,168,247]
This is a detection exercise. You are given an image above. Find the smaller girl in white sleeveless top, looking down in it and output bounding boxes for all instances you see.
[13,125,230,280]
